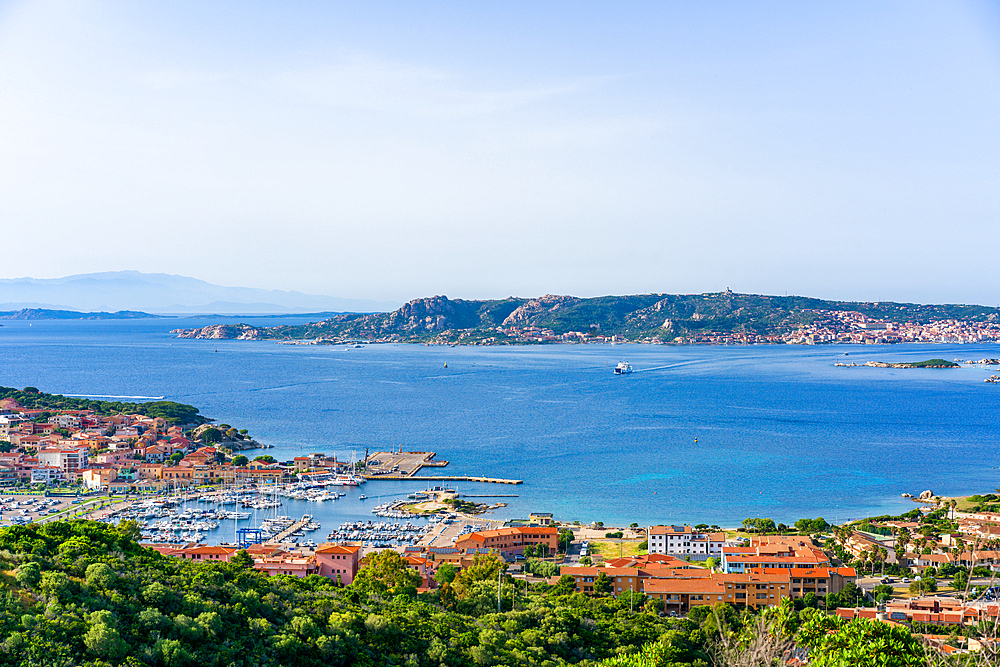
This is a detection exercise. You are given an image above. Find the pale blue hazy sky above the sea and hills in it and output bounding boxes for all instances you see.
[0,0,1000,305]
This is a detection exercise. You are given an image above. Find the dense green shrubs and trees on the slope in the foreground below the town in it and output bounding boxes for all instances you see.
[0,521,944,667]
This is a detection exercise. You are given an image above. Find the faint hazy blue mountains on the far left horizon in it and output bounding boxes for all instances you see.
[0,271,399,315]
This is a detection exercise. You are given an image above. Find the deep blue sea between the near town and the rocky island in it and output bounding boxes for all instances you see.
[0,318,1000,530]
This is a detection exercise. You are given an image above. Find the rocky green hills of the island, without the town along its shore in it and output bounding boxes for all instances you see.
[168,291,1000,343]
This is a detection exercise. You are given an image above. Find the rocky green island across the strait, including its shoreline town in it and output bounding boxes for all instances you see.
[172,290,1000,345]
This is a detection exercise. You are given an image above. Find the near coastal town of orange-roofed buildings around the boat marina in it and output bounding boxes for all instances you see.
[0,401,1000,656]
